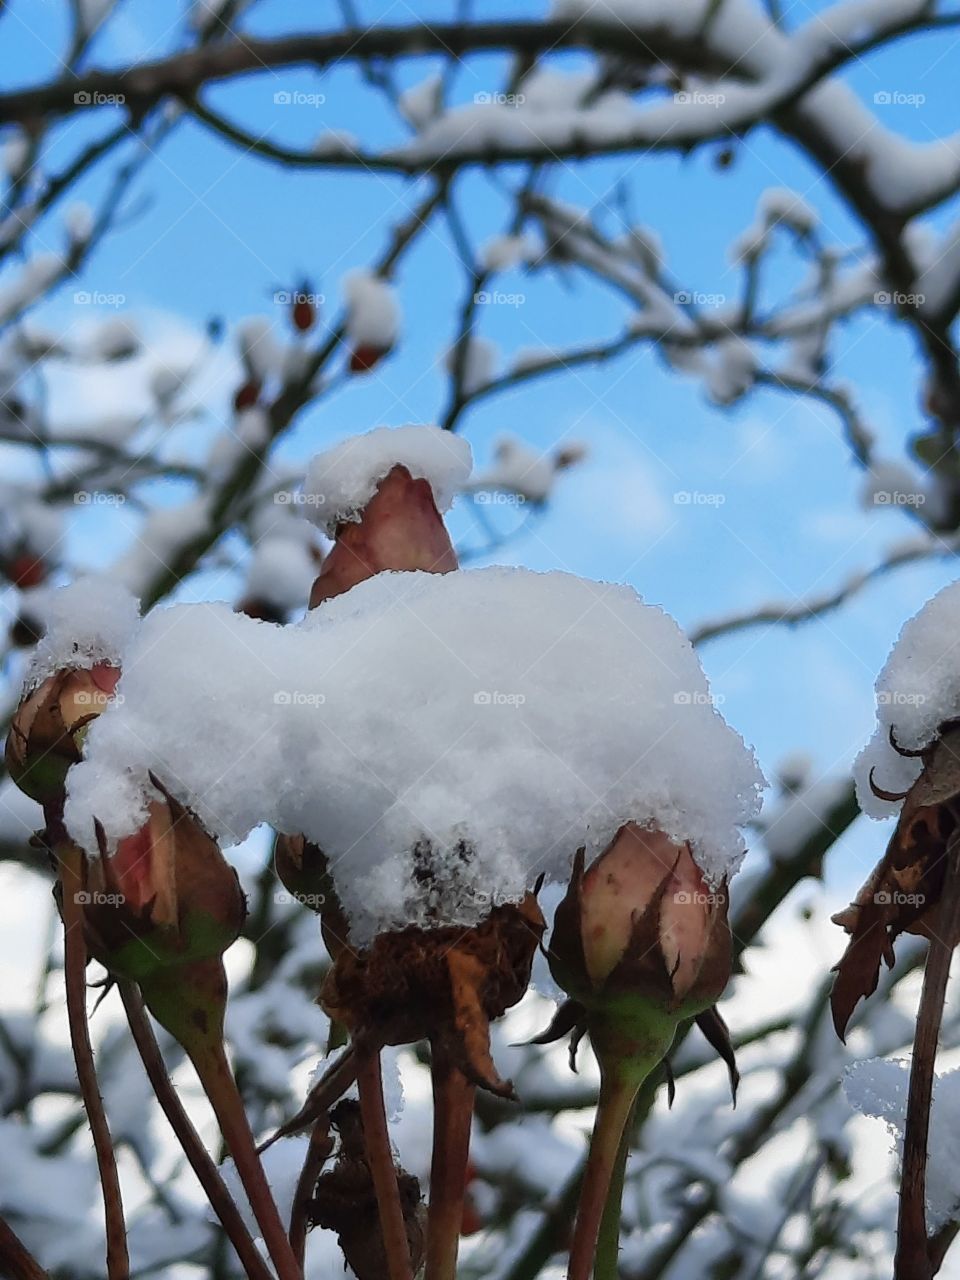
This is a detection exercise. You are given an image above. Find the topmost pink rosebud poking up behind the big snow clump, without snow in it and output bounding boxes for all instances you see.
[310,466,457,609]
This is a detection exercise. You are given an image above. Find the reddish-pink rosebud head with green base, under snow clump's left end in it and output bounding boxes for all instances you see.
[83,795,246,995]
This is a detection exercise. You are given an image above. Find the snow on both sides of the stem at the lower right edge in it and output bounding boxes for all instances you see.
[844,1059,960,1234]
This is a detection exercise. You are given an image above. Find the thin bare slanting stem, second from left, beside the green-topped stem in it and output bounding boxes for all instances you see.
[118,979,273,1280]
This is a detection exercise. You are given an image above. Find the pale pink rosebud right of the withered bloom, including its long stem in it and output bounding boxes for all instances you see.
[540,822,732,1280]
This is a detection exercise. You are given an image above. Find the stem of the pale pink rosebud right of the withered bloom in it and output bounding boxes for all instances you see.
[567,1065,640,1280]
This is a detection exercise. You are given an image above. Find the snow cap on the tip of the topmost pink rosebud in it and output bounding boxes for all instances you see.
[303,426,472,536]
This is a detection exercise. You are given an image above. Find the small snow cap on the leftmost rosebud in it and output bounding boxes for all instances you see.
[27,577,140,687]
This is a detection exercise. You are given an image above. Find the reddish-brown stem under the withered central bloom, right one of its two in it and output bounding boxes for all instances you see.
[425,1042,476,1280]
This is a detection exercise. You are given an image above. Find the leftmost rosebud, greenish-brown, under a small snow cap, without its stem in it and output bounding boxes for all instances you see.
[6,662,120,804]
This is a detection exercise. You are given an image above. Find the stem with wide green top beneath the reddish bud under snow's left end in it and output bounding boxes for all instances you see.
[141,959,303,1280]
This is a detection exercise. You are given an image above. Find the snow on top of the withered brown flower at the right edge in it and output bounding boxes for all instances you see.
[854,582,960,818]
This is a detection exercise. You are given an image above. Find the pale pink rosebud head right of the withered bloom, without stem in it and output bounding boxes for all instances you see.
[549,823,732,1059]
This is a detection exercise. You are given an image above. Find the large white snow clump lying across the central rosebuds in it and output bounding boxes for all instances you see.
[67,568,763,941]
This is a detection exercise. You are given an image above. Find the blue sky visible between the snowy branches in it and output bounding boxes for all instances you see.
[0,0,957,888]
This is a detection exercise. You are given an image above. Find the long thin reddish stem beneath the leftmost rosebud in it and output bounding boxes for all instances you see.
[56,845,131,1280]
